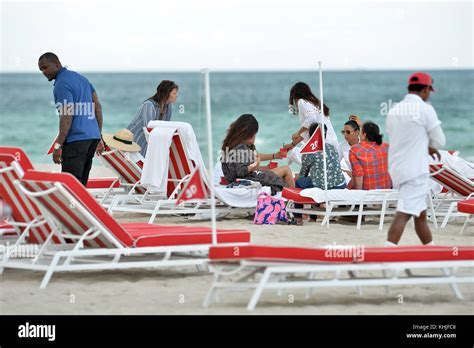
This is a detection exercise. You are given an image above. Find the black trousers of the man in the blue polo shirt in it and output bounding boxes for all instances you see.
[61,140,90,182]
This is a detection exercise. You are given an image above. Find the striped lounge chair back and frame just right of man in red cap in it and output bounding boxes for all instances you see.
[430,163,474,228]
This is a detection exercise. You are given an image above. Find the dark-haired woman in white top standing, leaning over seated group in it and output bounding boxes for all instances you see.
[284,82,342,159]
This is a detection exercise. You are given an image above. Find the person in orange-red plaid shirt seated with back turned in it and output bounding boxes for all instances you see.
[349,122,392,190]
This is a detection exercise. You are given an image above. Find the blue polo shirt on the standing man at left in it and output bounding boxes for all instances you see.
[53,68,100,143]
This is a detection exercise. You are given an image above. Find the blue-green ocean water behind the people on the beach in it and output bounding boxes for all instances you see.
[0,70,474,163]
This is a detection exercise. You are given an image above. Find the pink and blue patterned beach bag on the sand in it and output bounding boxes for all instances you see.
[253,192,288,225]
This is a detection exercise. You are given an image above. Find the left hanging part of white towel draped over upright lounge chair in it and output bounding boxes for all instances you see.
[141,122,176,192]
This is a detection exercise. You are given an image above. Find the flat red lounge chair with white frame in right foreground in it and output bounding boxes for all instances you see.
[203,245,474,310]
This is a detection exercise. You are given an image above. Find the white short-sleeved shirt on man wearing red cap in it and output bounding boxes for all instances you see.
[386,94,441,187]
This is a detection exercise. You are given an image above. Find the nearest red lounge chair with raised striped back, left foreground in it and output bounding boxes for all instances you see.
[0,171,250,288]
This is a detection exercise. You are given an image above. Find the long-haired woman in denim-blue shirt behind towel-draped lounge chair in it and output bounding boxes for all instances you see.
[127,80,179,156]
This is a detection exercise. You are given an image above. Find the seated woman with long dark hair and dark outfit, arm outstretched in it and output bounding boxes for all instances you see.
[221,114,295,194]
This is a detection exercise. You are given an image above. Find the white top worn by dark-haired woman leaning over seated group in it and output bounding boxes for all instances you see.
[298,99,343,160]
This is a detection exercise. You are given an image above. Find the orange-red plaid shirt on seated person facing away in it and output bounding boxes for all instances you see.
[349,141,392,190]
